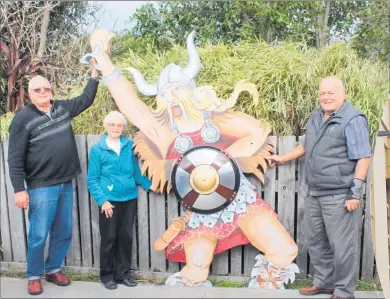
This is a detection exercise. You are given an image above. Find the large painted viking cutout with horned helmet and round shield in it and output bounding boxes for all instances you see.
[82,29,299,289]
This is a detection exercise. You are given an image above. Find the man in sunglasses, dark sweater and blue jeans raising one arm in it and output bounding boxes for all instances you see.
[8,62,99,295]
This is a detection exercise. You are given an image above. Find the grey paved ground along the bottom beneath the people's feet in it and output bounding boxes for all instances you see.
[0,277,384,298]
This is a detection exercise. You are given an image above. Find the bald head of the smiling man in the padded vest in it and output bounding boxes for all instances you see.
[319,76,345,115]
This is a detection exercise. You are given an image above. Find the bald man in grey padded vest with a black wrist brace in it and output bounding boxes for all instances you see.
[268,76,371,298]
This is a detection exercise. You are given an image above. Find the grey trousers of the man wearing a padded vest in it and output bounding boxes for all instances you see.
[305,194,359,298]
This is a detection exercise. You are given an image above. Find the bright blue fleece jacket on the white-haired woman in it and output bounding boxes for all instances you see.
[87,133,151,206]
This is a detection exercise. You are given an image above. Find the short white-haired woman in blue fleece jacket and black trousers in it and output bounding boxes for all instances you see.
[87,111,151,289]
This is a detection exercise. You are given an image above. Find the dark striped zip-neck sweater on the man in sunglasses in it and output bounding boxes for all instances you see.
[8,78,99,193]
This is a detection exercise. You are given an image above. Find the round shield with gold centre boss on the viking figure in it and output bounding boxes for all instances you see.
[171,146,240,214]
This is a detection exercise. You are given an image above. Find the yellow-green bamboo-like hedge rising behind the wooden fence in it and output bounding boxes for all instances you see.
[1,41,389,141]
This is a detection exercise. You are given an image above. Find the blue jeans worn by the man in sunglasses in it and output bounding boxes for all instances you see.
[27,182,73,280]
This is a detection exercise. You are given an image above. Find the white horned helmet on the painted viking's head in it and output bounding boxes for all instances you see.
[126,31,200,96]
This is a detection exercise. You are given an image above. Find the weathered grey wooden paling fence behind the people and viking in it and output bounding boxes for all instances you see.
[0,135,377,282]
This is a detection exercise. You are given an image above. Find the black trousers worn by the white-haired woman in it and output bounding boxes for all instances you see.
[99,199,137,283]
